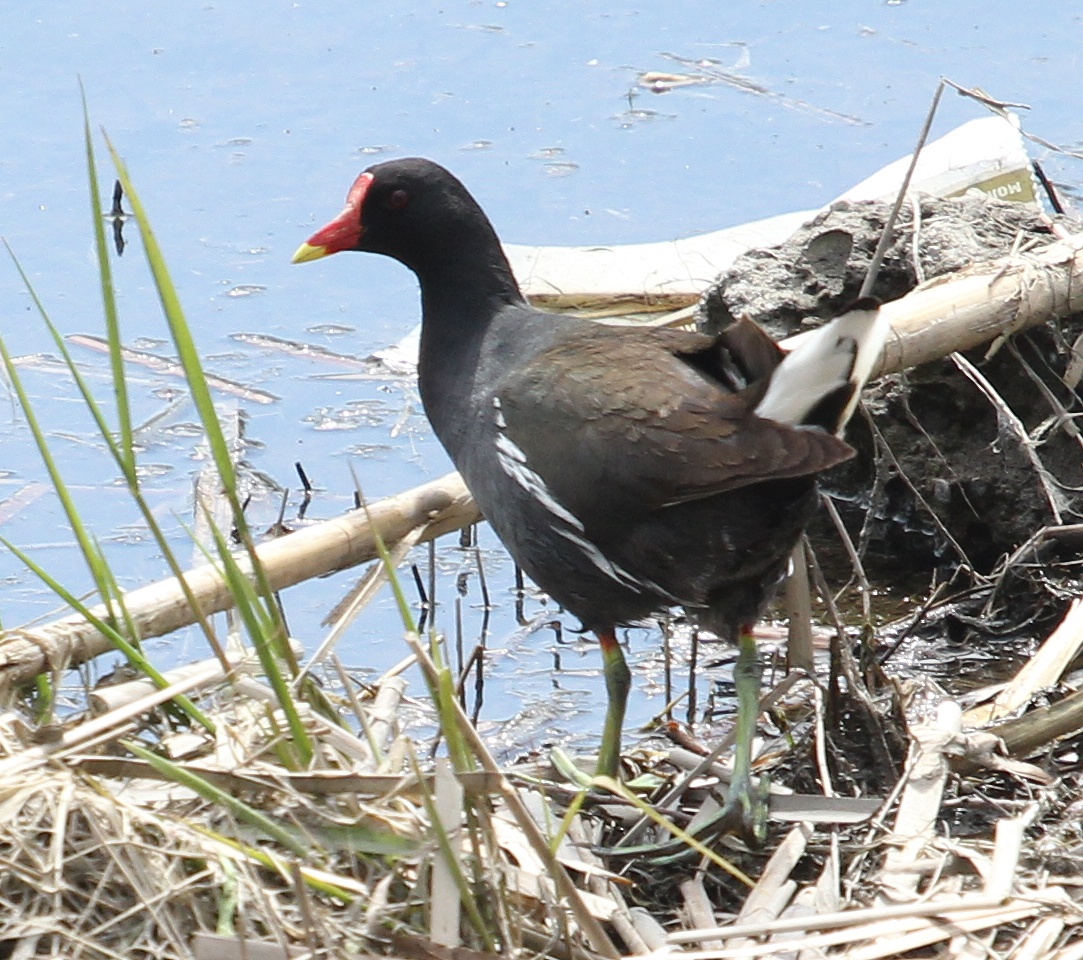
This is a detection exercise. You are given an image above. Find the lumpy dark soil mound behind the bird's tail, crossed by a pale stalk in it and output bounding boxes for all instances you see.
[700,197,1083,641]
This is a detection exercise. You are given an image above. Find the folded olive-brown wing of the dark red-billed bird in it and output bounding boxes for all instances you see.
[497,325,853,516]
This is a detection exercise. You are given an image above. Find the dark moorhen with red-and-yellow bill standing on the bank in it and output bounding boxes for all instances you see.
[293,159,886,840]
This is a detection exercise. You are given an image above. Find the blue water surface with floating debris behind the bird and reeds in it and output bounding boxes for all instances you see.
[0,0,1083,758]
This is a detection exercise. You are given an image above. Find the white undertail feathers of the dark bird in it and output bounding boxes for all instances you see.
[756,309,890,433]
